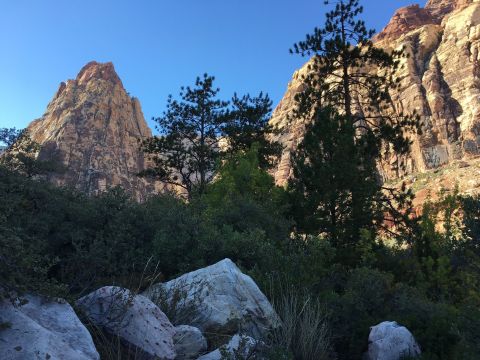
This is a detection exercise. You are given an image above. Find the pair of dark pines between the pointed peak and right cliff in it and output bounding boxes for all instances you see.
[140,74,281,198]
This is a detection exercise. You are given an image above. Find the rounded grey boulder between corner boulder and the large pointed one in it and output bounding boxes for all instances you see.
[77,286,176,359]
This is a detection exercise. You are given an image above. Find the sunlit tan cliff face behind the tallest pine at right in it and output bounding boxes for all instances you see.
[271,0,480,194]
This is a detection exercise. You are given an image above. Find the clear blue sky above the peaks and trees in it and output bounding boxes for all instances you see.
[0,0,425,128]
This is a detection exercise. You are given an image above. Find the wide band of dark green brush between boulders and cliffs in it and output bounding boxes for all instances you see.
[0,155,480,359]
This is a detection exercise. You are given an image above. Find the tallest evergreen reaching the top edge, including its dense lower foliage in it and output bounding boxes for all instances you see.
[290,0,417,249]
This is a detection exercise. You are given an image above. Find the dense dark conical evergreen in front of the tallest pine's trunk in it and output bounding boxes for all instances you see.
[289,107,383,263]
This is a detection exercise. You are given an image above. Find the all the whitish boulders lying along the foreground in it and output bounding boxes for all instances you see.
[0,259,420,360]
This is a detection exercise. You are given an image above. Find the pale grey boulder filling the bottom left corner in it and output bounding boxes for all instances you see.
[0,295,100,360]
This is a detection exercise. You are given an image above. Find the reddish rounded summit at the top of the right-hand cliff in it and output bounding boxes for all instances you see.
[374,4,439,41]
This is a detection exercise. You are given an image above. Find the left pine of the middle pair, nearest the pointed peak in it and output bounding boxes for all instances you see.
[141,74,228,197]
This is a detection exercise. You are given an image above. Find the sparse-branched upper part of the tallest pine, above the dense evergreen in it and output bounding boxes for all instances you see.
[290,0,417,158]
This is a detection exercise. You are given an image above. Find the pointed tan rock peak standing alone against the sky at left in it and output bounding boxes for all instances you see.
[28,61,161,200]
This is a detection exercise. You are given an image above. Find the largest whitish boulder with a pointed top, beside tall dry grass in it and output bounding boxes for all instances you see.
[144,259,279,338]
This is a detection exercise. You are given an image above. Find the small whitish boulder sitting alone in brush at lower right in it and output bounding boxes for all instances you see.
[367,321,421,360]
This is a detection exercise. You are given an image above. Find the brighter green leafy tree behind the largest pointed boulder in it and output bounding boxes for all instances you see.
[200,146,290,269]
